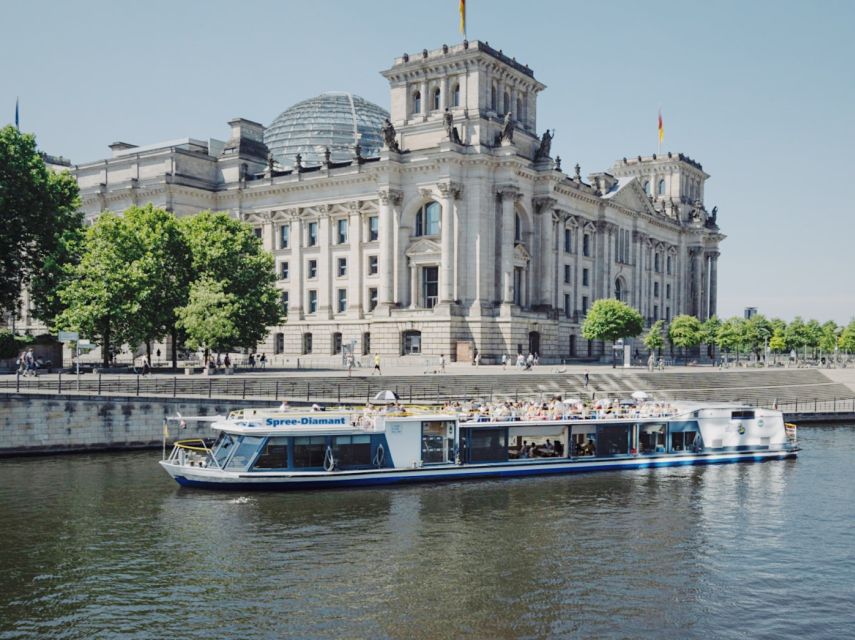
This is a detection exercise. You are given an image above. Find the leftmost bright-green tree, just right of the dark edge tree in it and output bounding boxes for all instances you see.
[55,213,145,366]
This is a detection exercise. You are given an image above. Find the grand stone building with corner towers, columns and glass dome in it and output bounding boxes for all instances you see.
[68,41,724,361]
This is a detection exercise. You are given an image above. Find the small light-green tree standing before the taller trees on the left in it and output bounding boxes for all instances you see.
[177,276,240,355]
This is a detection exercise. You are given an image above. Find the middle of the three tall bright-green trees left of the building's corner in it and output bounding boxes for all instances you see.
[123,204,192,367]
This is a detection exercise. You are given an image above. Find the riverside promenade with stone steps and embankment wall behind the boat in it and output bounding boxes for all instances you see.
[0,363,855,456]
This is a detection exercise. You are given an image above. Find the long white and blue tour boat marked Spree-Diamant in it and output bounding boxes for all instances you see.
[160,400,799,490]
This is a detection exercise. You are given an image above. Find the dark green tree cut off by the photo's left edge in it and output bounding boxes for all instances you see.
[0,126,82,321]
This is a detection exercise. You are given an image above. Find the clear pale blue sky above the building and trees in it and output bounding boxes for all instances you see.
[0,0,855,323]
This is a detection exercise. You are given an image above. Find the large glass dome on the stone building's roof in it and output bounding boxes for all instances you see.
[264,92,389,167]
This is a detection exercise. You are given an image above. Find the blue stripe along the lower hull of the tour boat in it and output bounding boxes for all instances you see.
[175,452,796,491]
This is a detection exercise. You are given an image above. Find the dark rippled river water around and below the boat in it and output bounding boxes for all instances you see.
[0,427,855,640]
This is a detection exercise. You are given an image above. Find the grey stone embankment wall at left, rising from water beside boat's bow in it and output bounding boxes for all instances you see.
[0,394,278,456]
